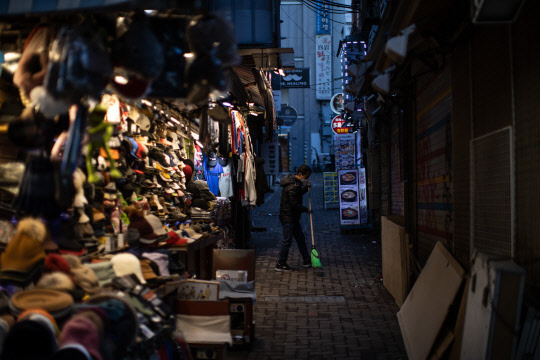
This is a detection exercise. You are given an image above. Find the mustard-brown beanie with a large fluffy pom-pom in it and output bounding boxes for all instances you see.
[0,218,47,272]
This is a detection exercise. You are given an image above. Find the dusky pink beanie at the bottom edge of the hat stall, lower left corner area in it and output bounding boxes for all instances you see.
[59,316,102,360]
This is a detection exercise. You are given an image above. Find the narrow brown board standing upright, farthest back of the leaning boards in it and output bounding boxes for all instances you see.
[381,216,409,307]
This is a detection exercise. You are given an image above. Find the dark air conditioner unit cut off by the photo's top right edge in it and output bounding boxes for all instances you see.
[472,0,524,24]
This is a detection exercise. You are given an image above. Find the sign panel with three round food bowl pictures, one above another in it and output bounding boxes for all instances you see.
[338,169,360,225]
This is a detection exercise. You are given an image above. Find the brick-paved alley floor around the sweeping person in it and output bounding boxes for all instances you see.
[229,174,407,360]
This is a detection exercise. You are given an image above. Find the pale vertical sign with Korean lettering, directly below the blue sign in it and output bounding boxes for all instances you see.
[315,35,332,100]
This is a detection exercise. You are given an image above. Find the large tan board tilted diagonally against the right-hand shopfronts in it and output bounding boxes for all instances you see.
[397,242,465,360]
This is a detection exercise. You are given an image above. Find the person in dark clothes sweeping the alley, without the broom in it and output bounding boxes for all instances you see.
[276,165,313,271]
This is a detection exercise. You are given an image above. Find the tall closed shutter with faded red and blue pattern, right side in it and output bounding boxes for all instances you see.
[416,66,453,264]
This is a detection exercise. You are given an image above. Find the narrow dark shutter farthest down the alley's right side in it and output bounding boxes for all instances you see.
[390,106,404,216]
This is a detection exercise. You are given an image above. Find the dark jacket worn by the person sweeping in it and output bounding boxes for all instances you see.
[279,175,309,223]
